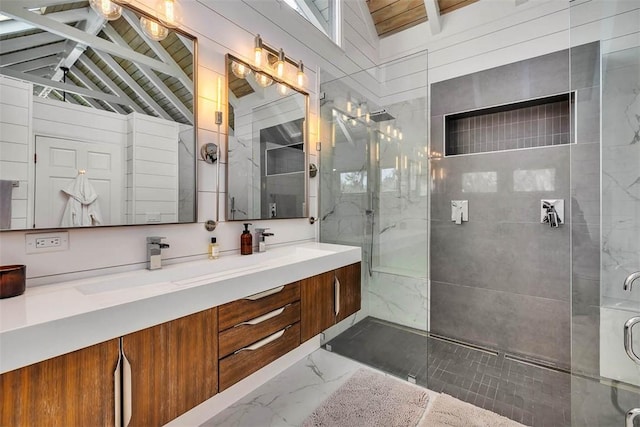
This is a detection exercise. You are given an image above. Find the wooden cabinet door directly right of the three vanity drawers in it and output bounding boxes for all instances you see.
[300,271,336,342]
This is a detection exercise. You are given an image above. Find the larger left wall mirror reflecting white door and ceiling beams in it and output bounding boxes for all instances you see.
[0,0,197,230]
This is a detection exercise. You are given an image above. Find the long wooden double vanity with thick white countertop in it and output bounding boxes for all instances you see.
[0,243,361,426]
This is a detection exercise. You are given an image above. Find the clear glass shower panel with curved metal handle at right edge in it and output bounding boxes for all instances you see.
[570,0,640,426]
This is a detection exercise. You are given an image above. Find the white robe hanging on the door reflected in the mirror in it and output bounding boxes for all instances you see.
[60,173,102,227]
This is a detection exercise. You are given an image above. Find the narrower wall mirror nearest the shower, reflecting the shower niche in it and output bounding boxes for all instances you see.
[227,55,308,221]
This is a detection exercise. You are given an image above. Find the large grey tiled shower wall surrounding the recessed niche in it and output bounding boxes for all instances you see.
[430,44,599,368]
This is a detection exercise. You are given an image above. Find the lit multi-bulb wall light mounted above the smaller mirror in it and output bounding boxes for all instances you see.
[251,34,307,88]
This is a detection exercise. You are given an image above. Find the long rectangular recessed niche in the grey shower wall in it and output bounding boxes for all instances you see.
[444,92,575,156]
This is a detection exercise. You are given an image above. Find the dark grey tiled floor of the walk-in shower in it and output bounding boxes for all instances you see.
[327,317,571,427]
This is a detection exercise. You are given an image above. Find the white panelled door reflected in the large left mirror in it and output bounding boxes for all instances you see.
[34,136,123,228]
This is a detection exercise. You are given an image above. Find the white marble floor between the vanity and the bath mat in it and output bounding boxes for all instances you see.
[202,349,438,427]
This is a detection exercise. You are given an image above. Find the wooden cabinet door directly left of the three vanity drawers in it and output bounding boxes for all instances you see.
[122,308,218,426]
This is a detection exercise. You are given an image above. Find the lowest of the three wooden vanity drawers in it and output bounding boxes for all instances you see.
[218,323,300,391]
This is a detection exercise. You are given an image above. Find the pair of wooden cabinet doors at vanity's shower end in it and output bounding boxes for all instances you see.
[300,262,361,342]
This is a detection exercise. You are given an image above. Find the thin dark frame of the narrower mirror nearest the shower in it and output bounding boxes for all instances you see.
[224,53,310,222]
